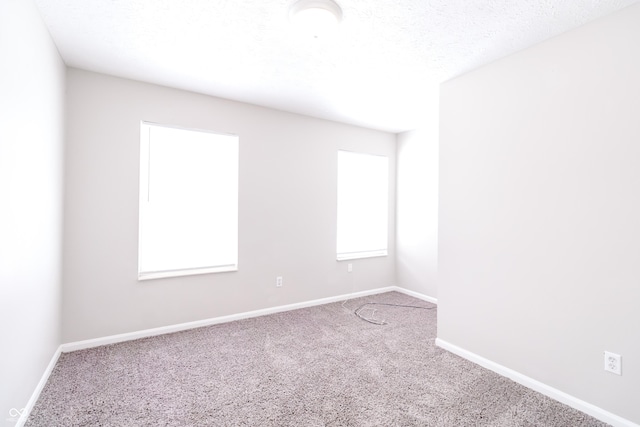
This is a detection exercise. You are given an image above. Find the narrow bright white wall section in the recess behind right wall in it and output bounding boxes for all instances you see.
[396,115,438,298]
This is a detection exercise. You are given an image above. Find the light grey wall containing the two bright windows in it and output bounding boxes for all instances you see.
[63,69,395,342]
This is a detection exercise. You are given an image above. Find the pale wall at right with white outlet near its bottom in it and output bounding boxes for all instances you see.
[438,4,640,423]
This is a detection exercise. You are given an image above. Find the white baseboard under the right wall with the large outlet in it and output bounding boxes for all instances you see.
[436,338,640,427]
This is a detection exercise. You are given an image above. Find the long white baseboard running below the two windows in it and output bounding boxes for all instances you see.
[61,286,402,353]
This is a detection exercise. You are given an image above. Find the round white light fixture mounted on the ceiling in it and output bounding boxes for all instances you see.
[289,0,342,38]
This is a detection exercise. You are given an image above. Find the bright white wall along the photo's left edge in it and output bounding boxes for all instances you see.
[0,0,64,425]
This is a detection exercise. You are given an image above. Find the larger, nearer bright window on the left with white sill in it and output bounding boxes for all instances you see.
[138,122,239,280]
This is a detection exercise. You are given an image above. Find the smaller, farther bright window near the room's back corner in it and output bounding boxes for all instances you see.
[337,151,389,261]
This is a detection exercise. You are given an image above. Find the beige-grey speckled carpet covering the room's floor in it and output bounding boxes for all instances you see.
[26,292,606,427]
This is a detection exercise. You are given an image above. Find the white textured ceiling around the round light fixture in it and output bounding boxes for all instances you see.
[35,0,639,132]
